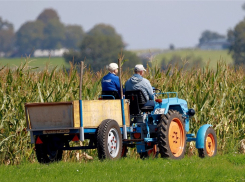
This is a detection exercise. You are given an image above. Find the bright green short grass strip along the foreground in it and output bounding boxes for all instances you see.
[0,155,245,182]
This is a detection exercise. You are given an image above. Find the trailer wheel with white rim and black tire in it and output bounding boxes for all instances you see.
[97,119,122,159]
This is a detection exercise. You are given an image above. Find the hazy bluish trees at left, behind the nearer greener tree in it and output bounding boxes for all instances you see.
[0,9,85,57]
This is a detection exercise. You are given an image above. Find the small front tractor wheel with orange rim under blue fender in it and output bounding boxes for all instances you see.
[198,127,217,158]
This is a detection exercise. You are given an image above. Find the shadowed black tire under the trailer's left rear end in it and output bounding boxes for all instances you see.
[35,136,63,163]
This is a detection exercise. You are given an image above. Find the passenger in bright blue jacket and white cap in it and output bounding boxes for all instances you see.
[101,63,121,97]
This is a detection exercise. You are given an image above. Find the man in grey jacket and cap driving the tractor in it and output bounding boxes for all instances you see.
[125,64,154,100]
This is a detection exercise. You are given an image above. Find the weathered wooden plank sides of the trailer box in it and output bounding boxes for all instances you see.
[25,100,130,130]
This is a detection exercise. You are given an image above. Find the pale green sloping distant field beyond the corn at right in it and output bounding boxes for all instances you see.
[149,49,233,69]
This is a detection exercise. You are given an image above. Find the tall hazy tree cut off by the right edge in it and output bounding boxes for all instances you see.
[227,19,245,66]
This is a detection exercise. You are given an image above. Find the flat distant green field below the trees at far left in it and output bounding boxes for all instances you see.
[0,57,69,69]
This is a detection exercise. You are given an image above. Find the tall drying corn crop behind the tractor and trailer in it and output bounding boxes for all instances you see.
[0,60,245,164]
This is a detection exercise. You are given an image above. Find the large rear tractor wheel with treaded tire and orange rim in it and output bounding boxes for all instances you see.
[157,110,186,159]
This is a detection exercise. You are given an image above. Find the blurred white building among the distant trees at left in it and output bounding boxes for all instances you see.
[33,48,68,57]
